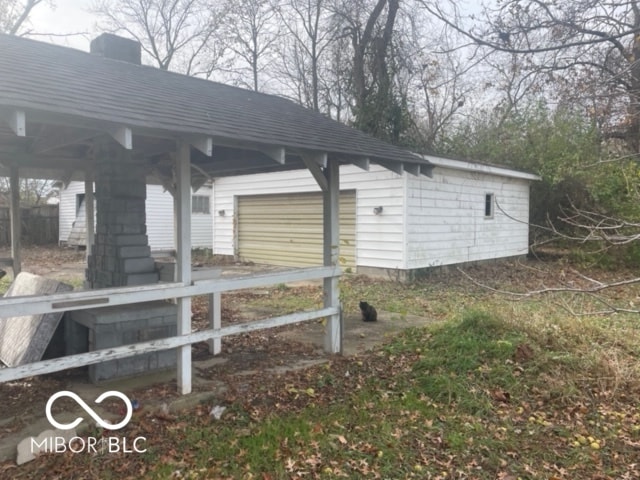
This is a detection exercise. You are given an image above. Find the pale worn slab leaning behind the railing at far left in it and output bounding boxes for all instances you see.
[0,272,73,367]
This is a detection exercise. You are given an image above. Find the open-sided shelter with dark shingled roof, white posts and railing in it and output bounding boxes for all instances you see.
[0,34,432,394]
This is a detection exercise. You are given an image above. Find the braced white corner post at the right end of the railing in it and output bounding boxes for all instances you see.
[322,158,342,353]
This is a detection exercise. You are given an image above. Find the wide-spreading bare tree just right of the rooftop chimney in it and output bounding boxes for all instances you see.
[93,0,225,77]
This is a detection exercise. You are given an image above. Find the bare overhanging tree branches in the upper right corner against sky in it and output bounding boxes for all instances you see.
[422,0,640,153]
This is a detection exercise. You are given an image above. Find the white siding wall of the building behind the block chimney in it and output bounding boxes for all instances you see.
[58,182,213,251]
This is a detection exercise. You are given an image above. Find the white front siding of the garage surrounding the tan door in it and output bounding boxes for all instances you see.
[213,165,404,268]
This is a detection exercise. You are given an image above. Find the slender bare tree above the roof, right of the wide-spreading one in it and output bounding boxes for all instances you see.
[225,0,280,91]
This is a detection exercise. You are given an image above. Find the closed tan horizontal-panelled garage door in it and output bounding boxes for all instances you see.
[237,190,356,269]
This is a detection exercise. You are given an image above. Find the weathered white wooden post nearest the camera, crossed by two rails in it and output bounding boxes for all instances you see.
[173,141,191,395]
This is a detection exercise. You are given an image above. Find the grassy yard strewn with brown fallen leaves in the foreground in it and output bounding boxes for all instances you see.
[0,253,640,480]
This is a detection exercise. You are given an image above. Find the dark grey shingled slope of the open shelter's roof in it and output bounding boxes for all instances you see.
[0,34,429,164]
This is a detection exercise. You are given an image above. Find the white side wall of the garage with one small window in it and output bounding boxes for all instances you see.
[406,167,530,269]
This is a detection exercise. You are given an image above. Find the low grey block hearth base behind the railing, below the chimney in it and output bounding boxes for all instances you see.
[65,301,177,383]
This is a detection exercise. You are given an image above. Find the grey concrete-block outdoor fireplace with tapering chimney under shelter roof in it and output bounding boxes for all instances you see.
[70,138,177,382]
